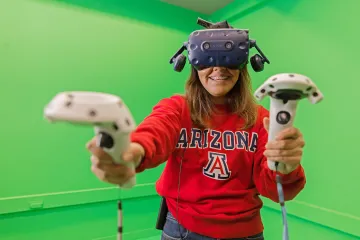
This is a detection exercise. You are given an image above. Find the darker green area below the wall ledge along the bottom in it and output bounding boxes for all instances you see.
[0,197,360,240]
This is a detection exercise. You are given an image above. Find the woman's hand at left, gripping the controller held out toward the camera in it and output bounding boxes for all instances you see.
[86,137,145,186]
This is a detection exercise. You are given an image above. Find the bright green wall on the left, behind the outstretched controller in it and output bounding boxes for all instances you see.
[0,0,205,239]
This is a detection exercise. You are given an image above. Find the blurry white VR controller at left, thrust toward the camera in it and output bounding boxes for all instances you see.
[44,91,136,188]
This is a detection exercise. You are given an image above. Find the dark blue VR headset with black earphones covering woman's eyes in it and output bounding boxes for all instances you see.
[170,18,270,72]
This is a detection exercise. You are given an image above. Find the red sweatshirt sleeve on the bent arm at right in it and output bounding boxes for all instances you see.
[253,107,306,203]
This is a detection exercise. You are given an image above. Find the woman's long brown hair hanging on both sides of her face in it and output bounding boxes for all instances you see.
[185,66,257,129]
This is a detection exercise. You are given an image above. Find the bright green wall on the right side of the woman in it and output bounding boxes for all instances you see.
[212,0,360,236]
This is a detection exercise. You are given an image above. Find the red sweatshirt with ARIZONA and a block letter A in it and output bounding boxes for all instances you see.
[131,96,305,238]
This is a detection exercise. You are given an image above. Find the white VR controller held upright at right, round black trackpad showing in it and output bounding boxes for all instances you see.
[255,73,323,171]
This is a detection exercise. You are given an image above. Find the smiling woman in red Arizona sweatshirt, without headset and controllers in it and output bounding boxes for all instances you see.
[88,64,305,240]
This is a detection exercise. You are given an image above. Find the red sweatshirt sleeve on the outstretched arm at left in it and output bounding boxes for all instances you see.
[130,96,184,173]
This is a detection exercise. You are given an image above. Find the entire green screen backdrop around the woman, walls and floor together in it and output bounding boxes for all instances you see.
[0,0,360,240]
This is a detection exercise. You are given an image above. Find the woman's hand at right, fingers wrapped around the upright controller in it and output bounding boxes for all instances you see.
[264,118,305,174]
